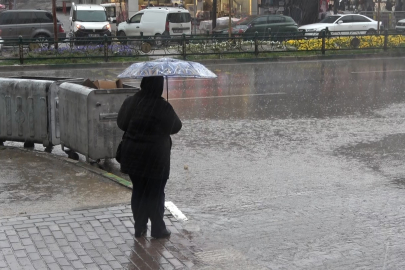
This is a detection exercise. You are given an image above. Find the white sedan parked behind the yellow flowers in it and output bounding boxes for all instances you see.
[298,14,383,37]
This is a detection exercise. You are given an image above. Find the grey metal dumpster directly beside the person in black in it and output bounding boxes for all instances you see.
[59,82,140,161]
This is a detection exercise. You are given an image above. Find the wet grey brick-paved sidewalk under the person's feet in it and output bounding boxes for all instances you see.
[0,205,199,270]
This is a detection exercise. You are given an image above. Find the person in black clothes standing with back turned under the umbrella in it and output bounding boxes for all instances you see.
[117,76,182,238]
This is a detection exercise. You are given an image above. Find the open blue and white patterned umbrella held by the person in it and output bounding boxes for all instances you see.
[118,58,217,100]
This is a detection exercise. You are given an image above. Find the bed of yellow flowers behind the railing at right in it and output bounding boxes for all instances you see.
[286,35,405,51]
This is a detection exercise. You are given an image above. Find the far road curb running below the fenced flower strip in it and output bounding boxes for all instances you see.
[0,52,405,72]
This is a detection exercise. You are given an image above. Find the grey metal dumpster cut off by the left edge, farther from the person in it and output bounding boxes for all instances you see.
[0,76,84,152]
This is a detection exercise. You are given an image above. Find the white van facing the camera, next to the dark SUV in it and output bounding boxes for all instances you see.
[69,3,111,42]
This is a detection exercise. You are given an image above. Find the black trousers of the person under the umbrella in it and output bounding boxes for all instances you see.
[129,174,167,234]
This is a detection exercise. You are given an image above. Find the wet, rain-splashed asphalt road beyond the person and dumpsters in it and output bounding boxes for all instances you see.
[0,58,405,269]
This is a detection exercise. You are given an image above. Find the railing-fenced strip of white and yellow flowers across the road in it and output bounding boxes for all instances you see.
[0,29,405,64]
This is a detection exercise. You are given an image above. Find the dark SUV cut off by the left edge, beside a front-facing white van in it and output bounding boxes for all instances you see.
[0,9,66,43]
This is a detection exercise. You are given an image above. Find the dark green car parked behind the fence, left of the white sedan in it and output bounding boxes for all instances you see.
[212,15,298,38]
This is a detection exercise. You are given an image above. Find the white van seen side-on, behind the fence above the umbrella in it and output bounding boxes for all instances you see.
[117,7,191,42]
